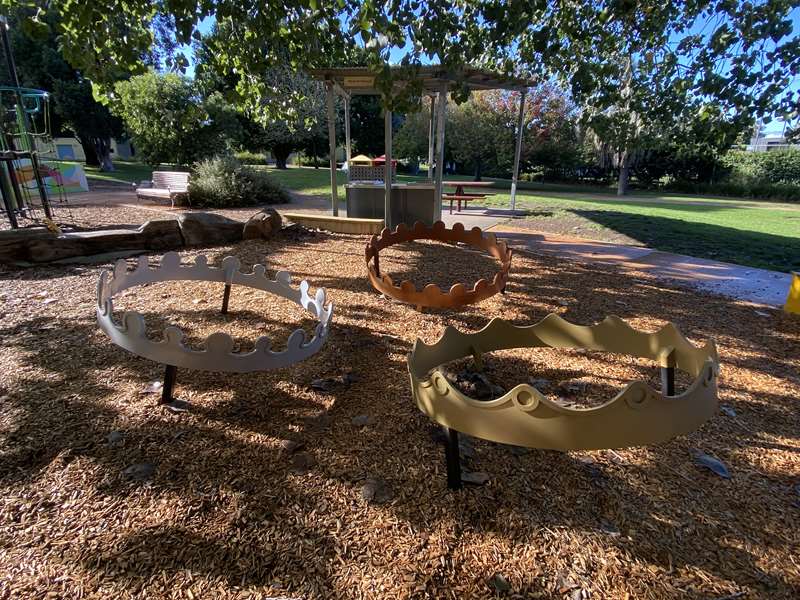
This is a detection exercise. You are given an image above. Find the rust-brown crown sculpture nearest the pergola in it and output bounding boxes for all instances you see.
[365,221,511,308]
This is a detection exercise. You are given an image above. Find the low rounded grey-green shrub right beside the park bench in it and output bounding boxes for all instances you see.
[189,156,289,208]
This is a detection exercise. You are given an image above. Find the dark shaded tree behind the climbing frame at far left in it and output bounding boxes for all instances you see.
[0,11,123,171]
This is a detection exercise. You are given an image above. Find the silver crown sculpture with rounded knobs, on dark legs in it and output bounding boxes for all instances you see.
[97,252,333,401]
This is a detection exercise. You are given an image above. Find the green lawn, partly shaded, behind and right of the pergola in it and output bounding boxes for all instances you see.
[268,168,800,271]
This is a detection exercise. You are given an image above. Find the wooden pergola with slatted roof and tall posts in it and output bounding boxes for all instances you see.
[311,65,535,227]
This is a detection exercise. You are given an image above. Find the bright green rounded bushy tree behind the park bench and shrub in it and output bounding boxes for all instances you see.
[112,72,240,166]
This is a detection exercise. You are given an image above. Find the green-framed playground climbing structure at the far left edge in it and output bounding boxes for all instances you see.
[0,16,65,228]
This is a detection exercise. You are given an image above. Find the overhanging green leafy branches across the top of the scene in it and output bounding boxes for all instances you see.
[9,0,800,191]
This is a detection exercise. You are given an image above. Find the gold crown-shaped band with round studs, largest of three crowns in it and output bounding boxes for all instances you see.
[408,314,719,451]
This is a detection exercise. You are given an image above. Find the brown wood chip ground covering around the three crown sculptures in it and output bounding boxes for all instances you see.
[0,209,800,599]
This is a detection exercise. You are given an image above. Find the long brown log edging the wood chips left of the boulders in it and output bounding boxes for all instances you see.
[0,219,183,264]
